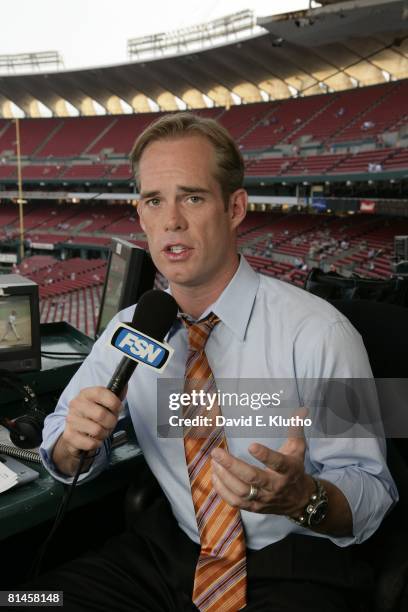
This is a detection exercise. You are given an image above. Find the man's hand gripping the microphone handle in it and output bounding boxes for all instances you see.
[52,387,125,475]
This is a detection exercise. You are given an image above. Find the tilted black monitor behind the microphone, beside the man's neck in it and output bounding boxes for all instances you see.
[96,238,156,338]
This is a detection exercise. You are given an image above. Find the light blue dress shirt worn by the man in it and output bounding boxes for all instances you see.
[40,257,398,549]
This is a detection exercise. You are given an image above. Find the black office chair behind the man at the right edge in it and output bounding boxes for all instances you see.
[331,300,408,612]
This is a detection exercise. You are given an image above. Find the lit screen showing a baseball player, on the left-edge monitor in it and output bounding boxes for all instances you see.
[0,295,32,351]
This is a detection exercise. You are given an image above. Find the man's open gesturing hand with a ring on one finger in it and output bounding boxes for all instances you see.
[211,411,315,516]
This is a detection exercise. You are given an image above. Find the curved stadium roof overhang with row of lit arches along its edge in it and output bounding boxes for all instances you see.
[0,0,408,117]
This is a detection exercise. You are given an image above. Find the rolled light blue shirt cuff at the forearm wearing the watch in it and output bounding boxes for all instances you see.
[320,466,398,547]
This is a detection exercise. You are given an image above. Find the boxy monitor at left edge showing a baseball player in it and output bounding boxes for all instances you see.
[0,274,41,372]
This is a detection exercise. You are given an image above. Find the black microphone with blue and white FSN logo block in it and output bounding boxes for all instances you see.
[107,289,178,397]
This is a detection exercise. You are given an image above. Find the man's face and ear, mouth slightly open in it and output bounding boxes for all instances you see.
[138,135,246,287]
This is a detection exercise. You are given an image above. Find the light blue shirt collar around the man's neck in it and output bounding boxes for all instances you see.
[166,255,259,341]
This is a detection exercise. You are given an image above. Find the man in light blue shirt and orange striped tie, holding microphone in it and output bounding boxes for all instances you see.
[41,113,397,612]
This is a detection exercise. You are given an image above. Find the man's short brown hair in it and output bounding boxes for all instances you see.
[130,112,244,207]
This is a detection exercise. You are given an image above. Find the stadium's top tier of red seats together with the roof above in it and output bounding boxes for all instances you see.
[0,0,408,189]
